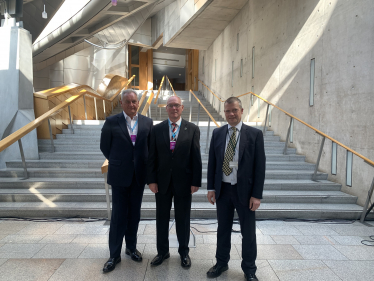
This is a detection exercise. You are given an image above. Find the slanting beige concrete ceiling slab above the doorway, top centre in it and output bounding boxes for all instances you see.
[165,0,248,50]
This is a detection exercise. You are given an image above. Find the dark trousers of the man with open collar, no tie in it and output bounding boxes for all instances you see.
[109,173,144,258]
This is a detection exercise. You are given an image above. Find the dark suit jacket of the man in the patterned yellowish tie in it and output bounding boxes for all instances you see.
[208,123,266,206]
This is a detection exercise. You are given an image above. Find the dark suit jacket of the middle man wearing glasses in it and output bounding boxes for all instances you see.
[147,119,202,196]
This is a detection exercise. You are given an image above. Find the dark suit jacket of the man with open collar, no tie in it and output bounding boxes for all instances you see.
[100,112,153,187]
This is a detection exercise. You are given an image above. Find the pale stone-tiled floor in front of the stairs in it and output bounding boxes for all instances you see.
[0,220,374,281]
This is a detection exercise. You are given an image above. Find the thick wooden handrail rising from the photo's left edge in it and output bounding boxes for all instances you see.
[0,89,87,152]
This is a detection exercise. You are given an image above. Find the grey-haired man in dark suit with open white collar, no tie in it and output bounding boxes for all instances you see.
[100,90,153,272]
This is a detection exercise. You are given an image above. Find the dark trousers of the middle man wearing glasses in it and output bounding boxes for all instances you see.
[156,180,192,256]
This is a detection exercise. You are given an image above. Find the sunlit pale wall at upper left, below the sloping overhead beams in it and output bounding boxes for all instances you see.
[34,46,128,92]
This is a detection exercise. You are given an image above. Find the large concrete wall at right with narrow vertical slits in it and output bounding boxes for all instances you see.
[199,0,374,205]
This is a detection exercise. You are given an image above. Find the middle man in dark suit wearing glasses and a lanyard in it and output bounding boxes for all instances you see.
[147,96,202,268]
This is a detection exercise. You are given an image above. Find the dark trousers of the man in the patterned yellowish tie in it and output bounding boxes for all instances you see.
[216,182,257,274]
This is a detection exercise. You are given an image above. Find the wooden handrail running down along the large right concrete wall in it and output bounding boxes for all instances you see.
[198,78,374,166]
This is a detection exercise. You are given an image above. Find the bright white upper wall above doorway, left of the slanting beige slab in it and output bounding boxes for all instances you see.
[152,0,208,45]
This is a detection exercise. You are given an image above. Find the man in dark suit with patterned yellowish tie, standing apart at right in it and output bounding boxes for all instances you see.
[207,97,266,281]
